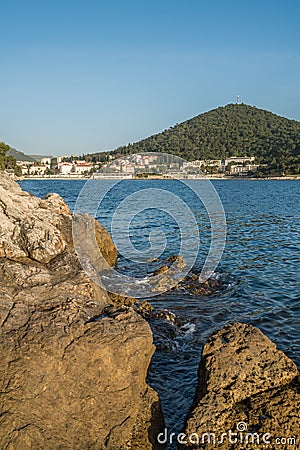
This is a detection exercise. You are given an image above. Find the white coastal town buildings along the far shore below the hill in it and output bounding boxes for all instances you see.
[17,153,259,178]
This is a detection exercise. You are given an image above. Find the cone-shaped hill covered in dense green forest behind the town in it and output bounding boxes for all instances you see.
[88,104,300,172]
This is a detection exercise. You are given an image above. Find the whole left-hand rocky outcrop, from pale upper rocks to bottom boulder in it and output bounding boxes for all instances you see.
[0,174,162,450]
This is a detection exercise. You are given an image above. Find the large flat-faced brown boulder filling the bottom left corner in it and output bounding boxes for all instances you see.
[0,310,164,449]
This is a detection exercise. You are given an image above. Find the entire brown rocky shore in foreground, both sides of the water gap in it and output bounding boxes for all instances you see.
[0,174,300,450]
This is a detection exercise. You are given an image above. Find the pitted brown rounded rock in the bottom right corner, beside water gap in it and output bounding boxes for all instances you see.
[180,323,300,450]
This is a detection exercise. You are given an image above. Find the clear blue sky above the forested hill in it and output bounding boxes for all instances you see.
[0,0,300,155]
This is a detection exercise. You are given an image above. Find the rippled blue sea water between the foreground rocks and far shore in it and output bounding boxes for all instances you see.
[20,180,300,442]
